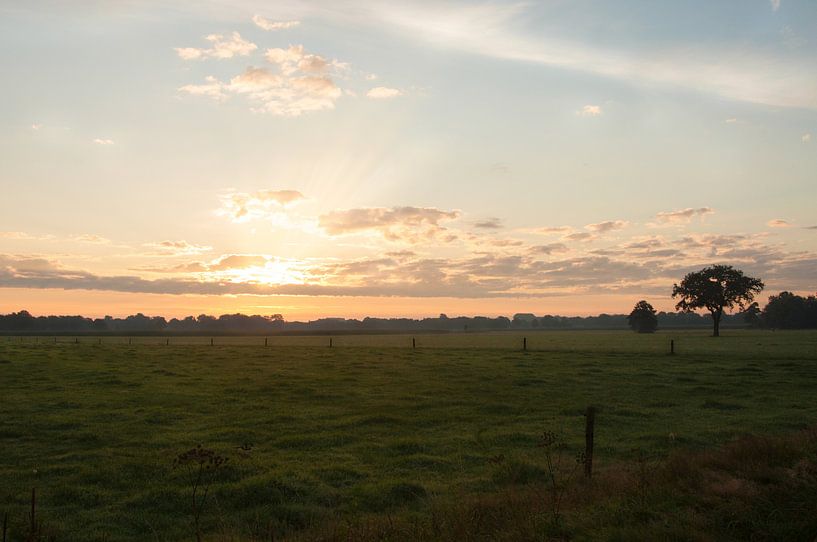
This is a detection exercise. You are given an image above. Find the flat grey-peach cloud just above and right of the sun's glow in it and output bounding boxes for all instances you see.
[318,207,460,243]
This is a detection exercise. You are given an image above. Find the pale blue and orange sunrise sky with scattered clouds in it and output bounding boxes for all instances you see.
[0,0,817,320]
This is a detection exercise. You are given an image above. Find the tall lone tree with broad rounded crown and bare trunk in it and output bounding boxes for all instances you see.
[672,265,763,337]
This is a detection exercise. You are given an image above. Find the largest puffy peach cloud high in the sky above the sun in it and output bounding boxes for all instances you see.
[178,45,345,117]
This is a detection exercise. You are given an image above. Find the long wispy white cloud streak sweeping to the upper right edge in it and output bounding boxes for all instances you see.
[362,2,817,109]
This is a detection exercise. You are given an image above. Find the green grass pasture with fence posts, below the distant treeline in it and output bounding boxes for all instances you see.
[0,331,817,541]
